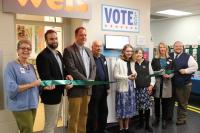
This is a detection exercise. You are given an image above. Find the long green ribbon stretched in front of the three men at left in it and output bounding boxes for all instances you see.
[40,80,116,86]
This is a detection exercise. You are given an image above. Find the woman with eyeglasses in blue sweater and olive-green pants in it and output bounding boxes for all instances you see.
[4,40,40,133]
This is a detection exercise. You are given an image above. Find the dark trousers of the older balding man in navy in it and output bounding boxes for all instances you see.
[86,88,108,133]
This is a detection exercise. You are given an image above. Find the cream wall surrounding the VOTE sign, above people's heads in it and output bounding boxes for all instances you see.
[65,0,150,47]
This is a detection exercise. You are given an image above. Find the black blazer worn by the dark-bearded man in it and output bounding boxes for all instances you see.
[36,48,65,104]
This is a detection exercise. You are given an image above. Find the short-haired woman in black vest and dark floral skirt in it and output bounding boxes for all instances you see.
[135,49,155,132]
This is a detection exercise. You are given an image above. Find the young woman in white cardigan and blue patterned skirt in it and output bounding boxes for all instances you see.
[114,44,137,133]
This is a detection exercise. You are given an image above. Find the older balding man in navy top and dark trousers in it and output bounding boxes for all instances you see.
[87,41,110,133]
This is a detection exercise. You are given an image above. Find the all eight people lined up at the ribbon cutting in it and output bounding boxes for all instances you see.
[4,27,198,133]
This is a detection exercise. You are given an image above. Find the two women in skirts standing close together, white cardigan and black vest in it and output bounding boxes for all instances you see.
[114,44,155,133]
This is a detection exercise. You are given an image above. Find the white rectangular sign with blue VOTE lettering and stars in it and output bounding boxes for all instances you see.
[102,5,140,32]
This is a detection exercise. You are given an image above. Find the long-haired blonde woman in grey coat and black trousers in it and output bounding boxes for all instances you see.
[151,42,173,129]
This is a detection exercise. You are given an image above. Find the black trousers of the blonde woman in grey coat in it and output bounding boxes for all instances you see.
[154,98,171,120]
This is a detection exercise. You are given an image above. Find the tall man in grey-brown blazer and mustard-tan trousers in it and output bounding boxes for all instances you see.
[63,27,96,133]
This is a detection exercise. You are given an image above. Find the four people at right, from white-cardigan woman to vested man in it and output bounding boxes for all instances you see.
[114,41,198,133]
